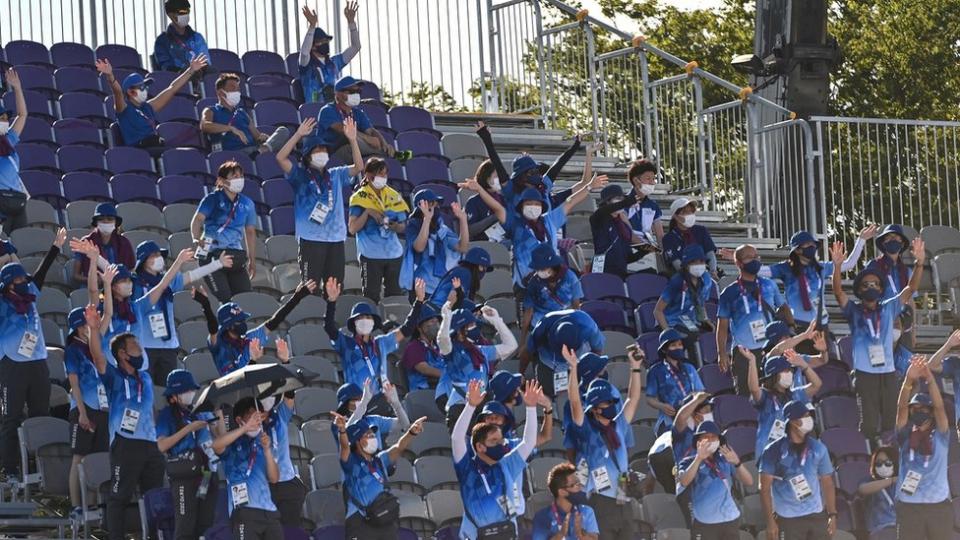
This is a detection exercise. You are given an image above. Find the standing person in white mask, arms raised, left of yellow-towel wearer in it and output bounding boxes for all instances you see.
[277,118,363,283]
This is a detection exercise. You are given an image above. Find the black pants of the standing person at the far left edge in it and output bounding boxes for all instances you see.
[0,356,50,474]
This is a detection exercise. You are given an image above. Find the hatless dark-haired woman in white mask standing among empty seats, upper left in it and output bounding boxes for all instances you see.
[190,160,257,302]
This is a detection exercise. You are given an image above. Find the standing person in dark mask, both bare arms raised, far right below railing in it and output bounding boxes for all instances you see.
[830,237,926,439]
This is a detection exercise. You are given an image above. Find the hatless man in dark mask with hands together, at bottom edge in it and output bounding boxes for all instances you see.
[533,463,600,540]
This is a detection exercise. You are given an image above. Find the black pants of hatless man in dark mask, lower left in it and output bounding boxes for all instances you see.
[107,435,166,540]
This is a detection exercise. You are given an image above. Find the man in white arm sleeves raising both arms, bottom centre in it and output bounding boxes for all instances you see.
[450,380,542,540]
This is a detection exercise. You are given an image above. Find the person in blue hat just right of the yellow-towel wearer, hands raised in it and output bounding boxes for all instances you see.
[400,189,470,300]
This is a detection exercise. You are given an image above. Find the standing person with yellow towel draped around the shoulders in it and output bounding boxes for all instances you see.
[347,158,410,303]
